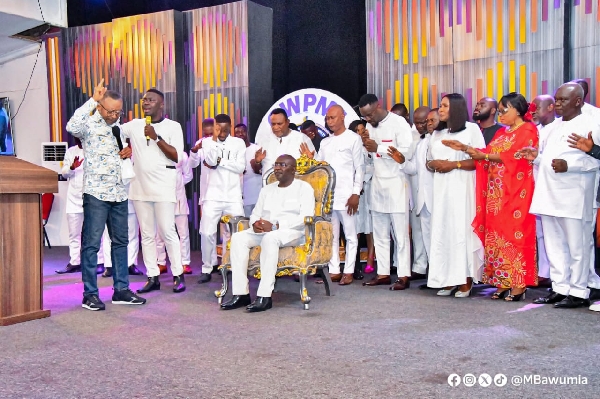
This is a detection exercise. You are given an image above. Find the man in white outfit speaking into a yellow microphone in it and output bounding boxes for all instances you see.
[122,89,185,293]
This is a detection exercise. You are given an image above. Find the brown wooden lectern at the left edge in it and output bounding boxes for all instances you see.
[0,157,58,326]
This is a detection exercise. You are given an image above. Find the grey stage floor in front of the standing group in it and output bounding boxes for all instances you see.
[0,247,600,398]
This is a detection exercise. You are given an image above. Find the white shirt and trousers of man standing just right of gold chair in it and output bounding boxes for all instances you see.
[315,130,364,274]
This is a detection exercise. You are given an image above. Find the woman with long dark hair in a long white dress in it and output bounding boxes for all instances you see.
[427,93,485,298]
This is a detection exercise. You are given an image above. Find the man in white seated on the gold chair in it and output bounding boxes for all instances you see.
[221,155,315,312]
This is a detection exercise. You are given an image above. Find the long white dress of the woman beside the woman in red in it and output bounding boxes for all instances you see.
[427,122,485,288]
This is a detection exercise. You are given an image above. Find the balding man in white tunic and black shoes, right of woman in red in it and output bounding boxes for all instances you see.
[520,83,600,308]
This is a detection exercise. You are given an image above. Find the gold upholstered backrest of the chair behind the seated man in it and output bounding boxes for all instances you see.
[265,155,335,221]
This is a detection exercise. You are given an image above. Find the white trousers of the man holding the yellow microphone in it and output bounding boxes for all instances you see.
[132,201,183,277]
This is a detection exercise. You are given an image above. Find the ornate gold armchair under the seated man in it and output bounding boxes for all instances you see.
[215,156,335,309]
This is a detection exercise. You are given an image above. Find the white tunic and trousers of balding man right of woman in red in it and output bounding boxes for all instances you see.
[530,114,600,298]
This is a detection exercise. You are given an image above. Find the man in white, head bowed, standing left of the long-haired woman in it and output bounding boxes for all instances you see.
[358,94,413,290]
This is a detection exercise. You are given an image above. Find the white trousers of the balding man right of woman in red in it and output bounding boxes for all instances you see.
[541,215,592,299]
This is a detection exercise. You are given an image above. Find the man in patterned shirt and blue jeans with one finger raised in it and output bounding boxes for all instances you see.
[67,79,146,310]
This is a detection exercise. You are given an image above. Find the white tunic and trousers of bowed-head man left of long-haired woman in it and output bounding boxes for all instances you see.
[367,112,414,277]
